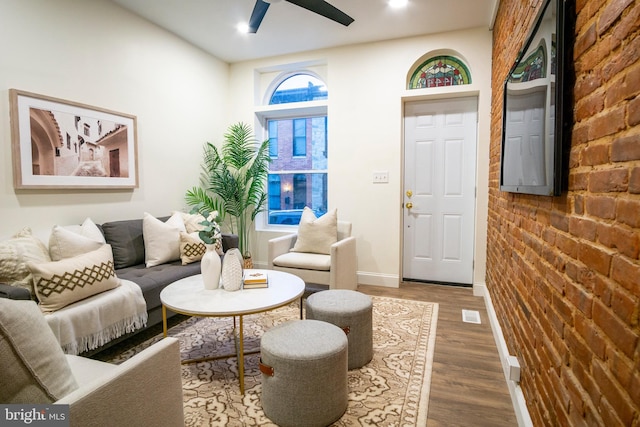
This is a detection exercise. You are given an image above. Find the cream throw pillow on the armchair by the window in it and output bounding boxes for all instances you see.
[291,207,338,255]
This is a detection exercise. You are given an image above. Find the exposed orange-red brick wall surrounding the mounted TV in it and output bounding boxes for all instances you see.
[486,0,640,426]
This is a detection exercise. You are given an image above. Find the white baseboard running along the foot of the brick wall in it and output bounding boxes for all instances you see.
[473,283,533,427]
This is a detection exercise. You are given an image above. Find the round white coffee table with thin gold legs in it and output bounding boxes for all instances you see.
[160,270,305,394]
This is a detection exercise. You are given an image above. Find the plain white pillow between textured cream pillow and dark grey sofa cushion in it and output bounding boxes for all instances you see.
[49,218,106,261]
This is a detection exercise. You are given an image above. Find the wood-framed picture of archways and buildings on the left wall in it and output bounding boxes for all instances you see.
[9,89,138,189]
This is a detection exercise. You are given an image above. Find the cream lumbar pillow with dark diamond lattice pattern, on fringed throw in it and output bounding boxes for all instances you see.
[28,244,120,312]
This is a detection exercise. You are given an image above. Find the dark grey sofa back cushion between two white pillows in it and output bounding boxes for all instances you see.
[102,218,144,270]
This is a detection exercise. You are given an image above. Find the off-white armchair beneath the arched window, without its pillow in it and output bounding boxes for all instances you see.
[267,221,358,290]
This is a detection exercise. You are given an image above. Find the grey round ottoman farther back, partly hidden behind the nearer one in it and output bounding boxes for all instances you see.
[307,289,373,369]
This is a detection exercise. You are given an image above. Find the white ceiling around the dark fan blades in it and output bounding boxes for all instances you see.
[111,0,500,63]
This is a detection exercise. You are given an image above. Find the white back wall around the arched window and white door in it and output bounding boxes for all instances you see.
[229,28,491,286]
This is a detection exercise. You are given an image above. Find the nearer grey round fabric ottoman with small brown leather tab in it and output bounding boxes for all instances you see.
[260,320,348,427]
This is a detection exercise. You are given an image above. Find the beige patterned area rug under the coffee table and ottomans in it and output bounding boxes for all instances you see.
[109,297,438,426]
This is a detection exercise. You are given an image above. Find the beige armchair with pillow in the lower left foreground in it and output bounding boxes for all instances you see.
[0,298,184,427]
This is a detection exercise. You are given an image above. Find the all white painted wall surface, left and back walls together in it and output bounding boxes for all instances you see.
[0,0,491,286]
